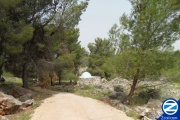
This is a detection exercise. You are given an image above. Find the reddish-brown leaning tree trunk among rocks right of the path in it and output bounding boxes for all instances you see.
[123,69,140,104]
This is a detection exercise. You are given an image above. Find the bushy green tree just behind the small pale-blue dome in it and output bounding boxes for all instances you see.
[88,38,114,77]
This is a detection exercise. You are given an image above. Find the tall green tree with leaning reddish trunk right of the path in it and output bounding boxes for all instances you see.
[107,0,180,103]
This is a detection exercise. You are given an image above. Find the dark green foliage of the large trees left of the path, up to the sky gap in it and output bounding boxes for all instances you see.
[0,0,88,86]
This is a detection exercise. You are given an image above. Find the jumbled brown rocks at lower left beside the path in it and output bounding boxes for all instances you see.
[0,86,35,120]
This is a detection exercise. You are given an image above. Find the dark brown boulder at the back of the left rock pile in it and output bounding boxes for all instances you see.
[12,86,32,98]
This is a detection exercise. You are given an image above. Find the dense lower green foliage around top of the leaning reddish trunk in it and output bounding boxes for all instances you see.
[105,50,173,80]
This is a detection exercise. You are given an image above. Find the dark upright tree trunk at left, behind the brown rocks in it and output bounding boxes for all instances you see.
[22,63,28,88]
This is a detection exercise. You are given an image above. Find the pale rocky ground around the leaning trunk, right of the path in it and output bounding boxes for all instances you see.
[79,78,180,120]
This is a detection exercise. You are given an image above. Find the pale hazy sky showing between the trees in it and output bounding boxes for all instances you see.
[78,0,180,50]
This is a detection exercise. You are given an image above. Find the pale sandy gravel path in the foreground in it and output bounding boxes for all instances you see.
[31,93,133,120]
